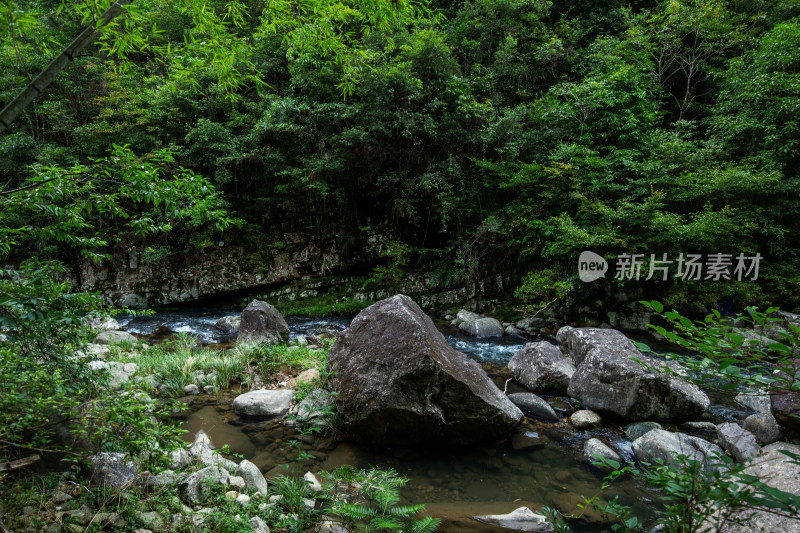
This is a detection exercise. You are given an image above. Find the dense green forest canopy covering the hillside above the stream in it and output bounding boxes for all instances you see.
[0,0,800,307]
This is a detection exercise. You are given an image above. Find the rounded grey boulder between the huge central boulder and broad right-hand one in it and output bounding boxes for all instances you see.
[508,341,575,396]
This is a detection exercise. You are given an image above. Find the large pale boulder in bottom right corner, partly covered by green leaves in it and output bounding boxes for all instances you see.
[711,442,800,533]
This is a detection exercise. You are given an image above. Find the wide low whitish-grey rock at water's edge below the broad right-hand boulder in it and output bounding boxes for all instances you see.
[631,429,724,469]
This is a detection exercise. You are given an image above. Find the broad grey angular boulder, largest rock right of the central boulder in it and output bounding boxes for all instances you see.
[558,328,710,421]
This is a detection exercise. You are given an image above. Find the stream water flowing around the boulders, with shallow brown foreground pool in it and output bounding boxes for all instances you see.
[121,308,657,533]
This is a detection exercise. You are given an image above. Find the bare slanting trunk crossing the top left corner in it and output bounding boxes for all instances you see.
[0,0,132,133]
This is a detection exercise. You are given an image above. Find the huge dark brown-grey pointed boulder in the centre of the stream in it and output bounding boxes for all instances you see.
[329,295,522,445]
